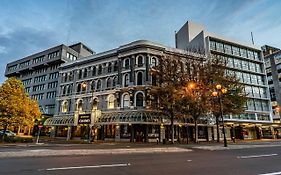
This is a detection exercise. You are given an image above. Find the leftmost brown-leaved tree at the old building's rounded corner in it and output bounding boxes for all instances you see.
[151,55,185,143]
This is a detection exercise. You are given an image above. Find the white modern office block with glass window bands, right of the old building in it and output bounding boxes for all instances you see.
[176,21,274,139]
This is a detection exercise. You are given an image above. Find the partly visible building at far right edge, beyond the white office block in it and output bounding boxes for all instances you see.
[262,45,281,125]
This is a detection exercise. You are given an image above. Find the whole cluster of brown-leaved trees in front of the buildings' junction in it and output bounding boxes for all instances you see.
[151,55,246,142]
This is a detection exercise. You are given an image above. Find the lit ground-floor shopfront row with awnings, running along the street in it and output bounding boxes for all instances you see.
[45,111,281,143]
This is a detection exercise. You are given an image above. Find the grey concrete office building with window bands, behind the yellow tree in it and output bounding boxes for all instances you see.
[5,43,94,116]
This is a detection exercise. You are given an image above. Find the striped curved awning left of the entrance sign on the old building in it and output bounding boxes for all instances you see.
[44,116,74,126]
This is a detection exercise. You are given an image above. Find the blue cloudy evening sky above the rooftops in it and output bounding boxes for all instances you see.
[0,0,281,83]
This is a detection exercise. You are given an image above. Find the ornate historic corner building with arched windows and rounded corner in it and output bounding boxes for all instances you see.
[44,40,212,142]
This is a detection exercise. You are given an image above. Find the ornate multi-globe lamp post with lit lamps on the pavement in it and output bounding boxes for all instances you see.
[212,84,227,147]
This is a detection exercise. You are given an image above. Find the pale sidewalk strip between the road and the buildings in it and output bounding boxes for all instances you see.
[0,139,281,158]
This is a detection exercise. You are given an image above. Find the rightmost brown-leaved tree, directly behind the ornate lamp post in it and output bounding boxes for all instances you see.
[206,56,247,142]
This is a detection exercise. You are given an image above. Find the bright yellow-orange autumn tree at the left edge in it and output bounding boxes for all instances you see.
[0,77,41,139]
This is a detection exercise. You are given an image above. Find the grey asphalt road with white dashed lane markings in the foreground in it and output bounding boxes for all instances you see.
[0,146,281,175]
